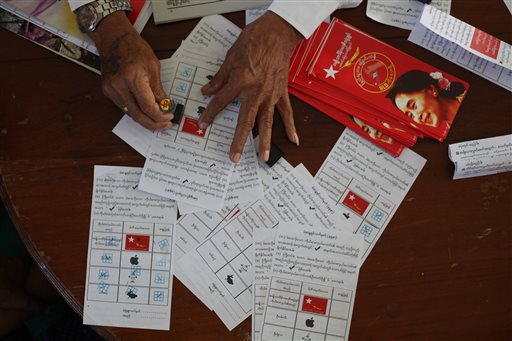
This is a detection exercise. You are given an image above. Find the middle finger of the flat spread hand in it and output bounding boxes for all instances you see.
[229,95,260,163]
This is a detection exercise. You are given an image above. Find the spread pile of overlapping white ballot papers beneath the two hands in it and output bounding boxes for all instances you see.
[84,16,425,340]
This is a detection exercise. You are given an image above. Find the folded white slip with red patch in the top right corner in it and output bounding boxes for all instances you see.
[409,6,512,91]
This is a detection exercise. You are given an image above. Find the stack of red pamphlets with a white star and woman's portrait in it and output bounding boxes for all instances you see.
[289,19,469,156]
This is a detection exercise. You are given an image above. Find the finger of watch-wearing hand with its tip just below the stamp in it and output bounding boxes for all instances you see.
[128,75,172,122]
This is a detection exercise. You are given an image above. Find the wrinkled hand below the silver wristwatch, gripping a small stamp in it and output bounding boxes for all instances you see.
[89,11,173,130]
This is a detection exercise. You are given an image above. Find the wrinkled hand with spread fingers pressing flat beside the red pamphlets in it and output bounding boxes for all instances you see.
[199,11,303,163]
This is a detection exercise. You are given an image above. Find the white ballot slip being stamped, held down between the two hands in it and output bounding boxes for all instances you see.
[139,46,263,211]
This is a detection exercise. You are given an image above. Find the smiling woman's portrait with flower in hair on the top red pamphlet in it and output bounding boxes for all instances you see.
[386,70,466,128]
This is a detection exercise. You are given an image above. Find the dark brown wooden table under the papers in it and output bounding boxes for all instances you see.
[0,0,512,340]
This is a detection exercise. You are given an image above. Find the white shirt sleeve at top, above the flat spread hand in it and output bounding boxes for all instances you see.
[268,0,363,38]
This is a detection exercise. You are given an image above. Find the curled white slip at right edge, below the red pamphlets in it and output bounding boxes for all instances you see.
[448,134,512,180]
